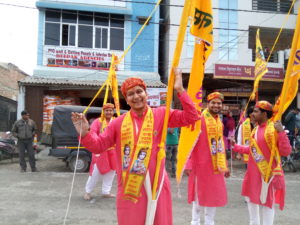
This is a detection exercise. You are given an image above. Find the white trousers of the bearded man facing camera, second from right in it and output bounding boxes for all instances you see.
[191,201,216,225]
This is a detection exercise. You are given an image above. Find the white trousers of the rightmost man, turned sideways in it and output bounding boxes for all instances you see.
[246,197,275,225]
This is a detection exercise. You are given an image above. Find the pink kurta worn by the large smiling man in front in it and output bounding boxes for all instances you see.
[82,92,198,225]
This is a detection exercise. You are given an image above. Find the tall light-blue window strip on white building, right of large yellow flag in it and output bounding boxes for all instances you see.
[218,0,238,61]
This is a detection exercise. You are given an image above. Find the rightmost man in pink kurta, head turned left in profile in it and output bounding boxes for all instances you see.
[233,101,291,225]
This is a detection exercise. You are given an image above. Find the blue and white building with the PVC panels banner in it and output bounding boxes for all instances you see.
[19,0,165,136]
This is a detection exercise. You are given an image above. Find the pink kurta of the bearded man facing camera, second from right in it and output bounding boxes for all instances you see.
[186,113,227,207]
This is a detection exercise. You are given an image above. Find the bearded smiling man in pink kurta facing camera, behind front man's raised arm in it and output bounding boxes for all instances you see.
[185,92,229,225]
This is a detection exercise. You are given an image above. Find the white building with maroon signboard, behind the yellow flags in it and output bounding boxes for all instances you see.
[161,0,300,114]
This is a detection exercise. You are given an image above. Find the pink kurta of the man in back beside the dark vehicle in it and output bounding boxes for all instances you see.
[90,119,116,176]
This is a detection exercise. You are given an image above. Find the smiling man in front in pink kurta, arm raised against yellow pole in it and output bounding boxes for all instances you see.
[72,70,198,225]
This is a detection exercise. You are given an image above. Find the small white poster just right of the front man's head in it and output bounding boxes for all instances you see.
[147,88,167,107]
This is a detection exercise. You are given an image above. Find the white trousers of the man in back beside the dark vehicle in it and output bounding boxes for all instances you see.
[85,164,116,195]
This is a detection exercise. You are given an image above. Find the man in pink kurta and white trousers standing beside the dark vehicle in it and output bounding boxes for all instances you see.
[84,103,116,200]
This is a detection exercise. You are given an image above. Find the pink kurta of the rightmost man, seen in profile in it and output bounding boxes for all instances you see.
[233,123,291,210]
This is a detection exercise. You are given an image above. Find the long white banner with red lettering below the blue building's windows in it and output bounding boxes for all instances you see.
[43,46,124,70]
